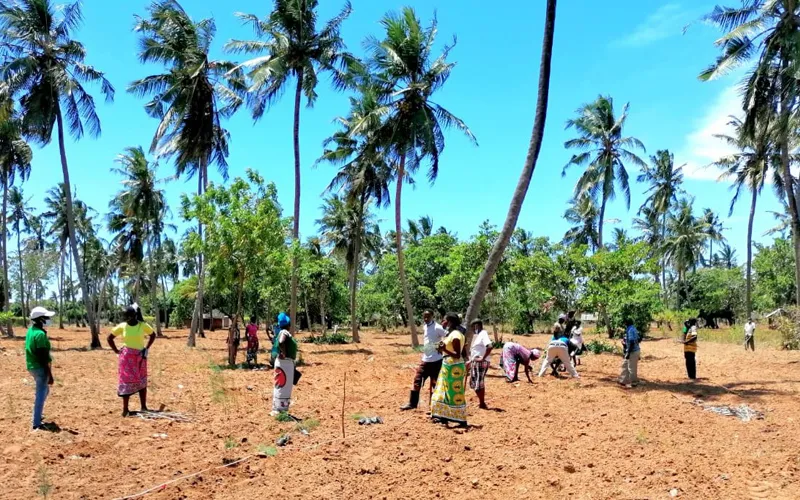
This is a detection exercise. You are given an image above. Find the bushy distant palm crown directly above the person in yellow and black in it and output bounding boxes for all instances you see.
[664,198,708,283]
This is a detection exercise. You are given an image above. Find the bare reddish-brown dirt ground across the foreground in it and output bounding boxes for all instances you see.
[0,329,800,499]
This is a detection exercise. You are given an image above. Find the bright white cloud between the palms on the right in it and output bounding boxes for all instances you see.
[675,85,742,181]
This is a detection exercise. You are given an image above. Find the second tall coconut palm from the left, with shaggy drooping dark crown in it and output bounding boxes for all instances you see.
[128,0,242,347]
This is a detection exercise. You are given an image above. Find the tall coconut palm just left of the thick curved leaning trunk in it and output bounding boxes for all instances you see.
[360,7,477,347]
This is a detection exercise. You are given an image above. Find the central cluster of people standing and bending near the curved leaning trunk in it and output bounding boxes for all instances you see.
[400,310,583,427]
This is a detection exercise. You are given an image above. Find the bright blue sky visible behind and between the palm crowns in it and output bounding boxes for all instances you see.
[18,0,779,260]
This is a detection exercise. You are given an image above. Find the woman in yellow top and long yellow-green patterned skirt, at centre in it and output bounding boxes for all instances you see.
[431,313,467,427]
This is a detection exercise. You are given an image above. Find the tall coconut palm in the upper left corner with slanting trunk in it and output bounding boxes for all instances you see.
[0,0,114,348]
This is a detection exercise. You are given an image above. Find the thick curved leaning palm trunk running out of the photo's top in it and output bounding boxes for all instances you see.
[465,0,557,345]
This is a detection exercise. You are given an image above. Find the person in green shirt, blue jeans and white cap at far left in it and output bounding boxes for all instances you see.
[25,306,56,430]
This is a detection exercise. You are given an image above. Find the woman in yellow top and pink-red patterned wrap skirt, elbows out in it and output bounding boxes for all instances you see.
[108,304,156,417]
